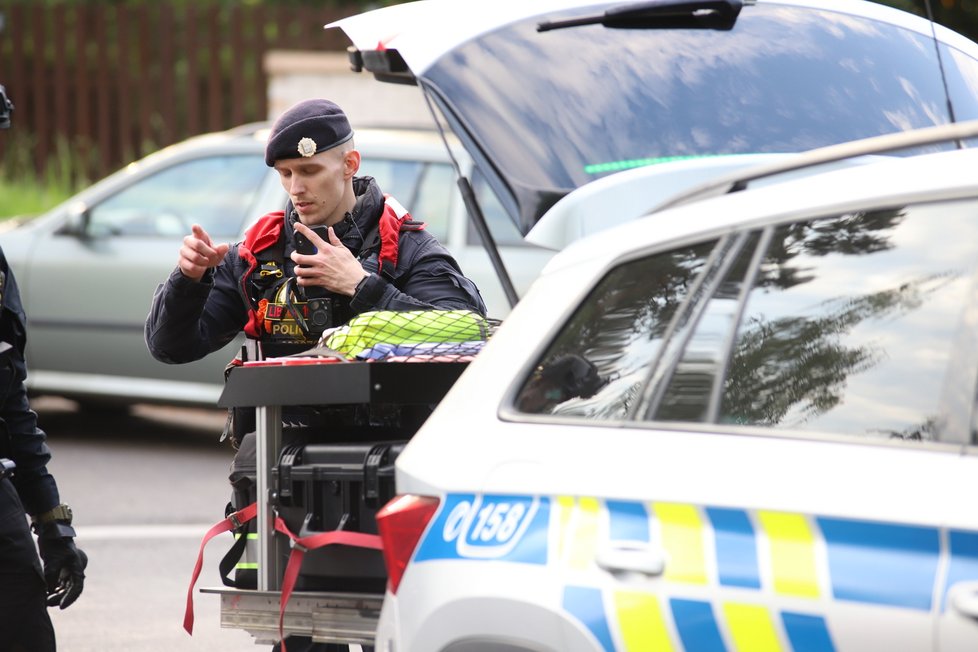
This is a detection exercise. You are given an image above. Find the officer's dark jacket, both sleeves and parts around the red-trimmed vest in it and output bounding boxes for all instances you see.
[145,177,486,363]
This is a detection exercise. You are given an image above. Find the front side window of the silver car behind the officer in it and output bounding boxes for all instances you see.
[88,154,268,238]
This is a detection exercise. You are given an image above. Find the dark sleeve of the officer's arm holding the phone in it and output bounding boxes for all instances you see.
[350,231,486,316]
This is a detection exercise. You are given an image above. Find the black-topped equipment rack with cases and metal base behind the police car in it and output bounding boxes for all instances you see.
[201,361,467,645]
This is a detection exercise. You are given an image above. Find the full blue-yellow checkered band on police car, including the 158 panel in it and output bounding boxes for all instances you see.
[414,494,978,652]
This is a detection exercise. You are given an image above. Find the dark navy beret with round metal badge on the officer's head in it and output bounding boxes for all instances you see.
[265,100,353,167]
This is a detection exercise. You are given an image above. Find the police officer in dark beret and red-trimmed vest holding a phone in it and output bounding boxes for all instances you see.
[145,99,486,652]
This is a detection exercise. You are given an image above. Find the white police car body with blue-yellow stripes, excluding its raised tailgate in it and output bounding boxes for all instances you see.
[368,117,978,652]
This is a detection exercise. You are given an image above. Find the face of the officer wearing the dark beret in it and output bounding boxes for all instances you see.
[275,146,360,226]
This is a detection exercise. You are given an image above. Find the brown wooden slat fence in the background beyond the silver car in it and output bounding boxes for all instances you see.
[0,0,362,183]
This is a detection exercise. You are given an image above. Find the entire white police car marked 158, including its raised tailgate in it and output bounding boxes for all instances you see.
[324,0,978,652]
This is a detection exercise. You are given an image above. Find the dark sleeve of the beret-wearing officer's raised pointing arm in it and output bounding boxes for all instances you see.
[144,252,248,364]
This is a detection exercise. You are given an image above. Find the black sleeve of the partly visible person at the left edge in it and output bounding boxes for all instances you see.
[0,252,61,515]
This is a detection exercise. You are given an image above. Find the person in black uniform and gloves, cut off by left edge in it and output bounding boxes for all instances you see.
[0,250,88,652]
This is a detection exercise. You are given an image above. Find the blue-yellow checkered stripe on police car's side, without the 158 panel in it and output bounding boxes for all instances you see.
[554,497,978,652]
